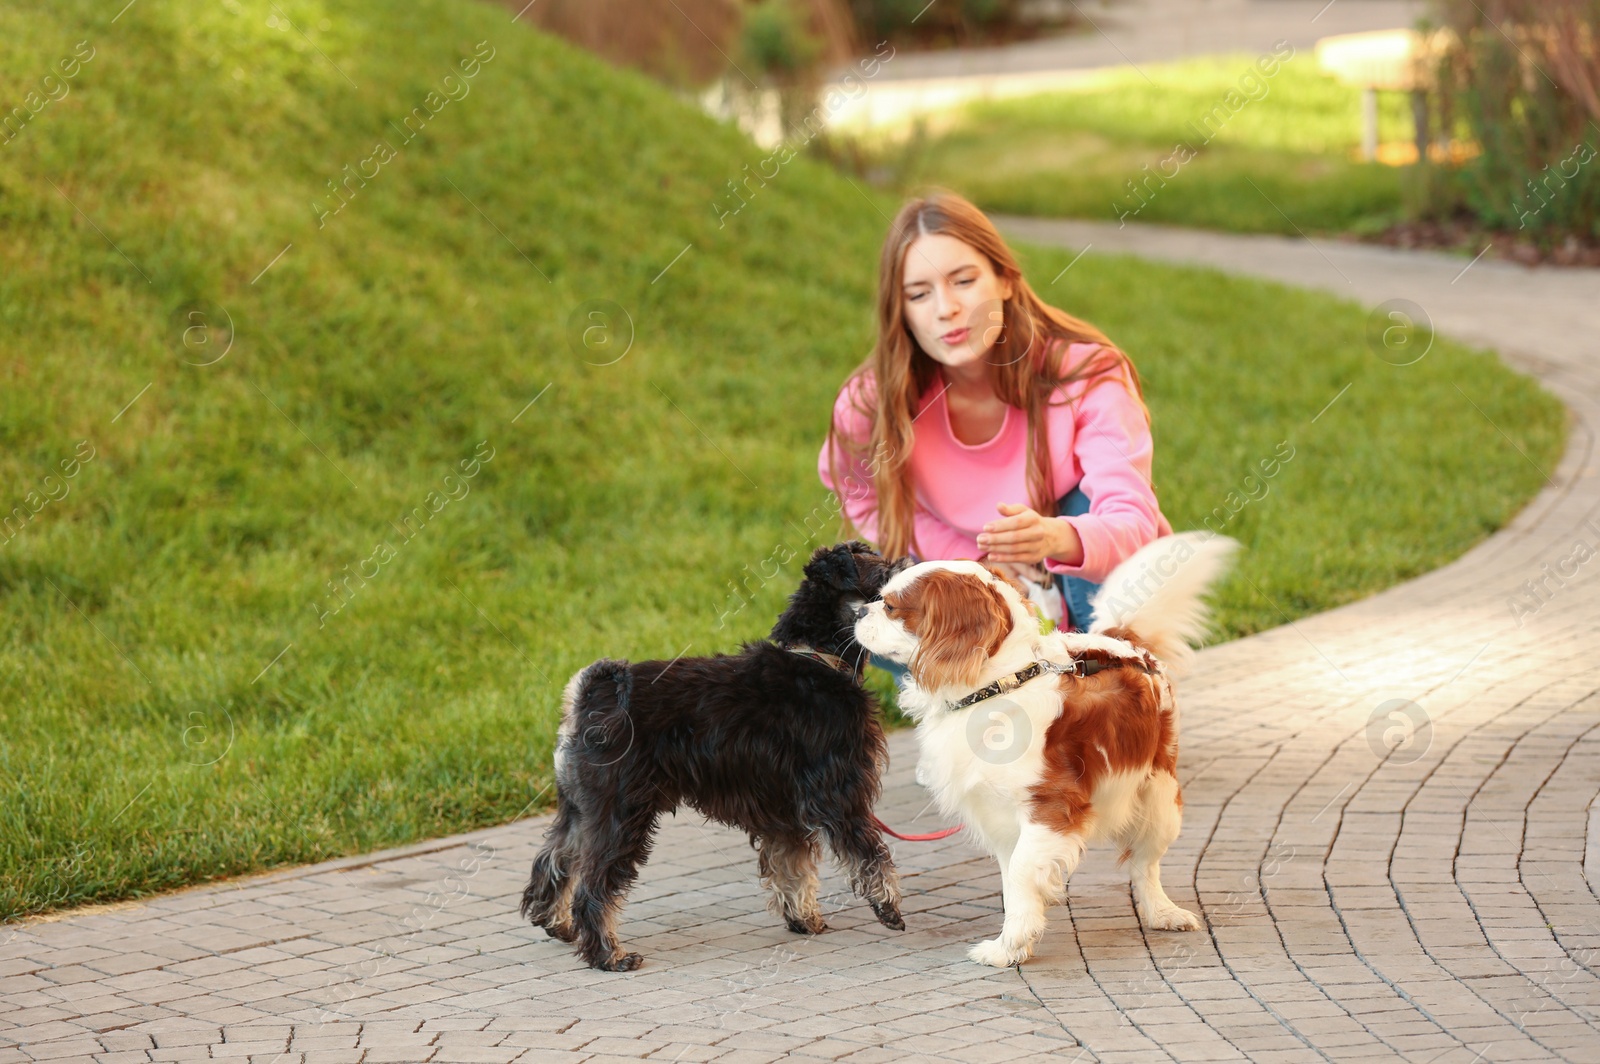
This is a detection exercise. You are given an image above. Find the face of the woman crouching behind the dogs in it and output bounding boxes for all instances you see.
[901,234,1011,366]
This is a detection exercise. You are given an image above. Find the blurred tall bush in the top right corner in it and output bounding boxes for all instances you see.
[1414,0,1600,245]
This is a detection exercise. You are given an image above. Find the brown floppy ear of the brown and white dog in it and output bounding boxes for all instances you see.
[910,571,1013,691]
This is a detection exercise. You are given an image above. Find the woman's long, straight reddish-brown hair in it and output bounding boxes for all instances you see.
[827,192,1150,558]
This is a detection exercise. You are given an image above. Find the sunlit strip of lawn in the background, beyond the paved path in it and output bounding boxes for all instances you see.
[866,51,1411,234]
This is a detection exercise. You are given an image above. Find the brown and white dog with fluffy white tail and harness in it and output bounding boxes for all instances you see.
[856,533,1238,968]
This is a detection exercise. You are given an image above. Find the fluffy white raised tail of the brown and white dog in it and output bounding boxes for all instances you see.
[1090,531,1238,674]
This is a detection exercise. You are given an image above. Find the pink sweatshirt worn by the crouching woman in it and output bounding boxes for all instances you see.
[818,344,1173,584]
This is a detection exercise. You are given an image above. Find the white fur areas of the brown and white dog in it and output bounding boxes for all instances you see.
[856,533,1238,966]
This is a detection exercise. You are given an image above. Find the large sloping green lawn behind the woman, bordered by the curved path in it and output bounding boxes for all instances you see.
[0,0,1565,917]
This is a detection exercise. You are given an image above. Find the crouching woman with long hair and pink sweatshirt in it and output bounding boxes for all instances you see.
[818,192,1173,640]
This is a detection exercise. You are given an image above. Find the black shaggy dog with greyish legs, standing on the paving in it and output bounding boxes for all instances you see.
[522,541,906,971]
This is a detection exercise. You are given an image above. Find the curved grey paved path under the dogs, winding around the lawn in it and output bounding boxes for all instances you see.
[0,219,1600,1064]
